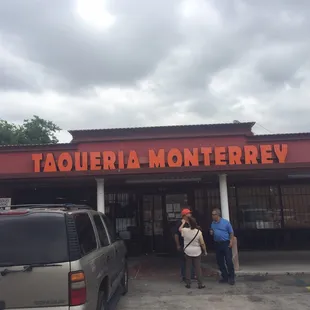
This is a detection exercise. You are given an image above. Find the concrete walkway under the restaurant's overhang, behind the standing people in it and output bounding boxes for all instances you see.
[129,251,310,279]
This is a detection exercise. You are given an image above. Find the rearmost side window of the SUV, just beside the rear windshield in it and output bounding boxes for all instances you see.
[73,213,97,256]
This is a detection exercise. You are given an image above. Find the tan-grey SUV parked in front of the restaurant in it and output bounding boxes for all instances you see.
[0,205,128,310]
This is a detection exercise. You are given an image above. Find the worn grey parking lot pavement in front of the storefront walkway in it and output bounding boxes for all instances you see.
[116,275,310,310]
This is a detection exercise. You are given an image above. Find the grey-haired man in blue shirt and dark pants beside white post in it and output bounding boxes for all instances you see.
[210,209,235,285]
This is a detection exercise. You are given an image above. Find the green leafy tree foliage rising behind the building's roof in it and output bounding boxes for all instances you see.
[0,115,61,145]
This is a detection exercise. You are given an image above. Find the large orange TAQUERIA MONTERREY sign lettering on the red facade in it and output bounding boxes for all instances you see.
[32,144,288,172]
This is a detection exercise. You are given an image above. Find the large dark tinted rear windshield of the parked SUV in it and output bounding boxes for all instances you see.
[0,212,69,266]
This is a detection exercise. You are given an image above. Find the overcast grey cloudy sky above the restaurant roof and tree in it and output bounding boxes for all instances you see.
[0,0,310,141]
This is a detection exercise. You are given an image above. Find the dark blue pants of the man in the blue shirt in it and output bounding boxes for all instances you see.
[215,241,235,281]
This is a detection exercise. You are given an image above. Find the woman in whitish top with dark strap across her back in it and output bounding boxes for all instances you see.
[179,217,207,289]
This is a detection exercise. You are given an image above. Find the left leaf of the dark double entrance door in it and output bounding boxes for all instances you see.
[142,194,165,253]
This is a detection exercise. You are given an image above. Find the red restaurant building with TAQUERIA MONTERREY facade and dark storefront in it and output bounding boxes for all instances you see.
[0,123,310,254]
